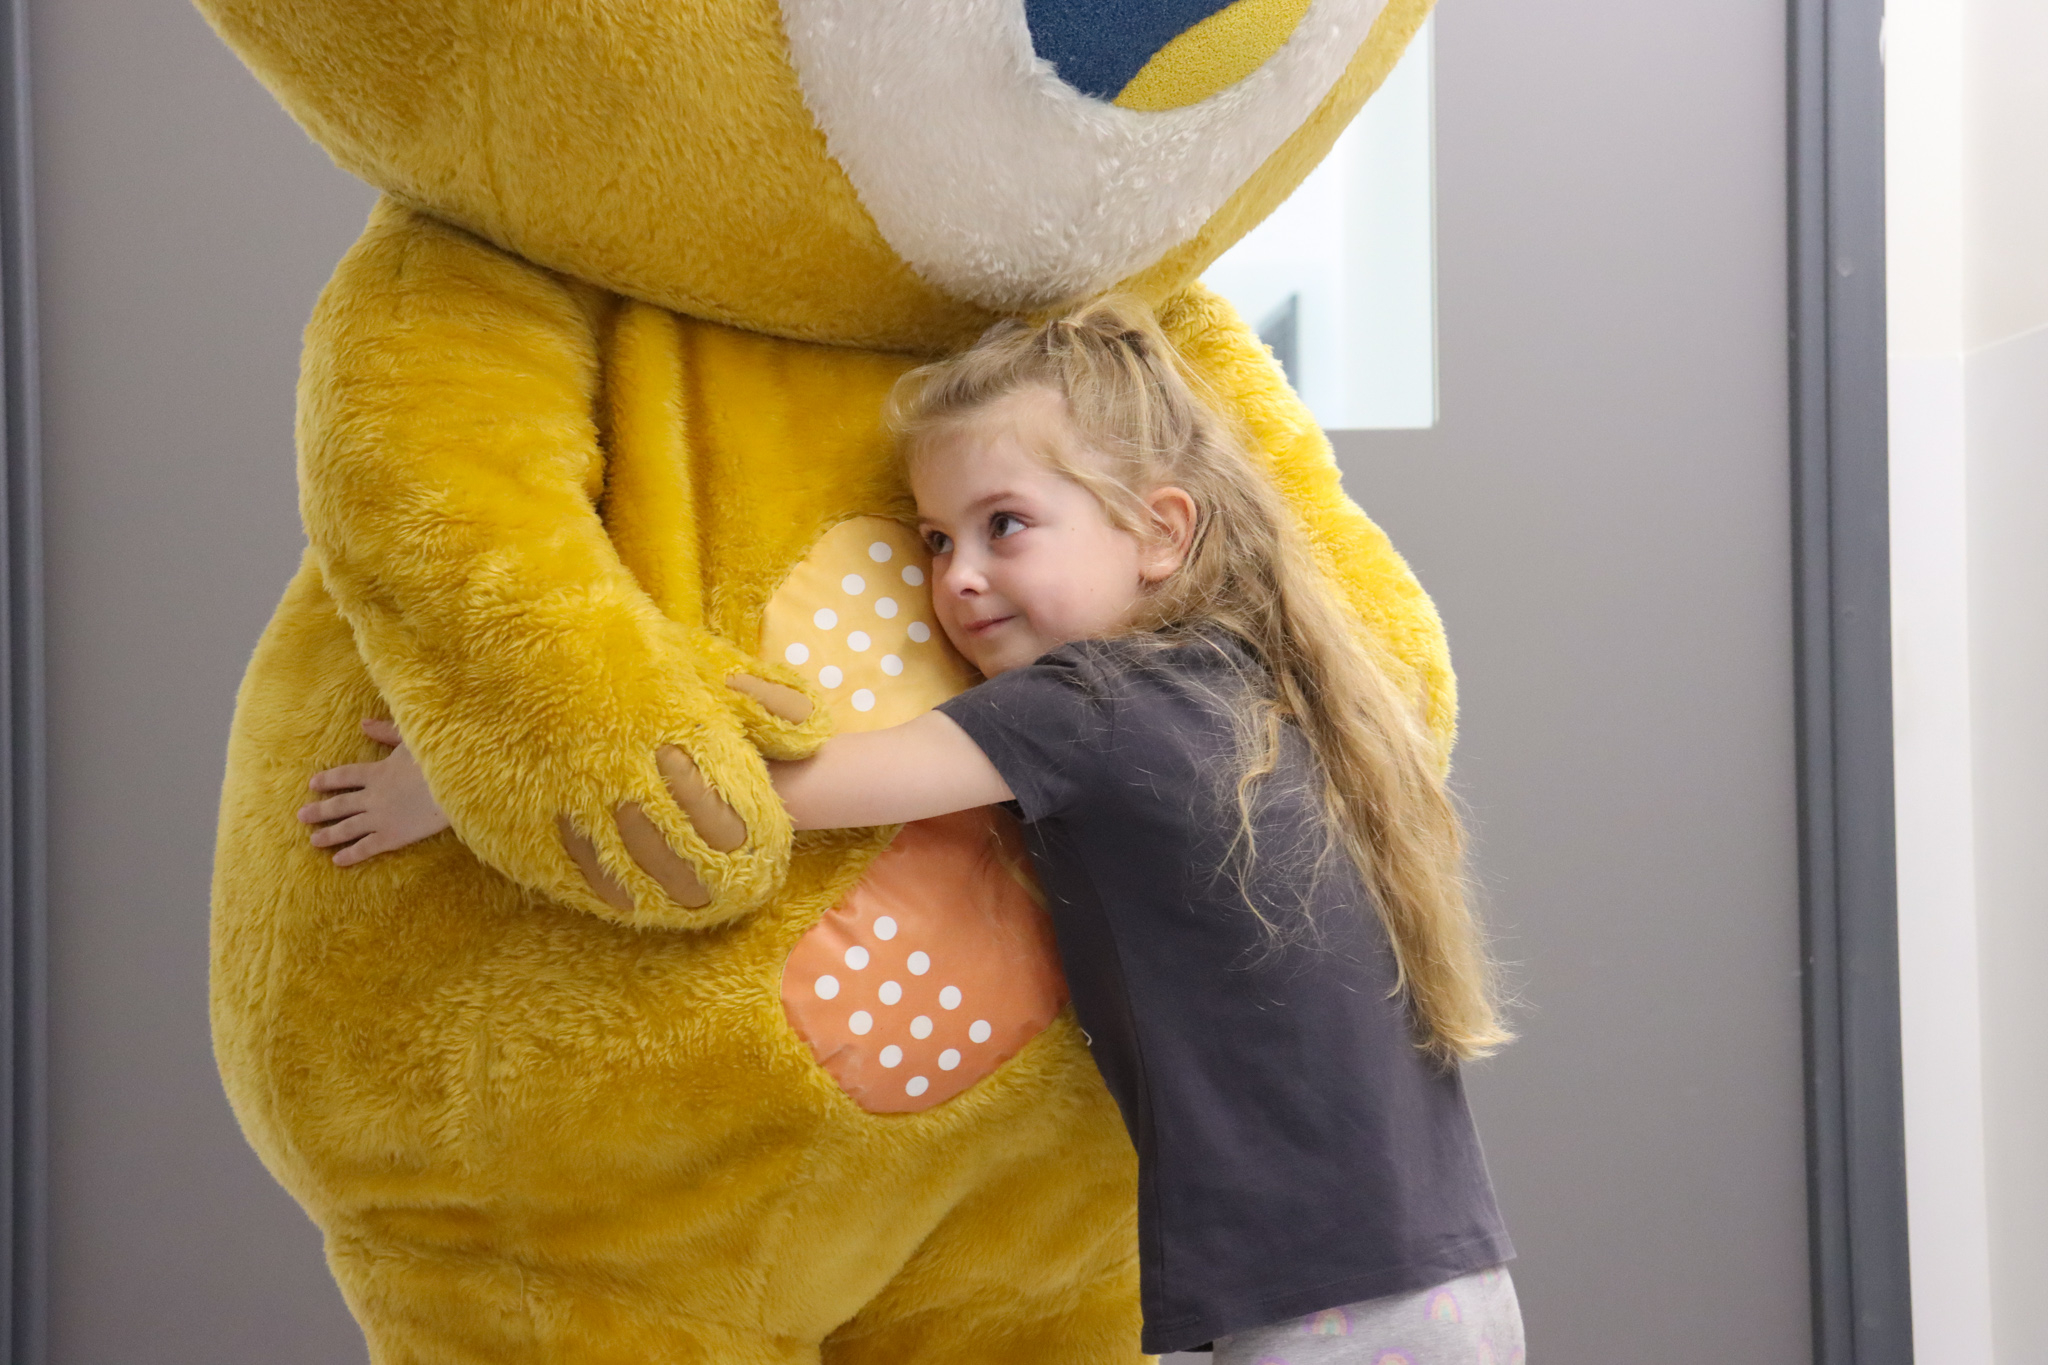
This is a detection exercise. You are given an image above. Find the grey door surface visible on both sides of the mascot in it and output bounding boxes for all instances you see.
[33,0,1806,1365]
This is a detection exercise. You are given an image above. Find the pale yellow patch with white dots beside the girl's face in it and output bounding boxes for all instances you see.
[762,516,981,733]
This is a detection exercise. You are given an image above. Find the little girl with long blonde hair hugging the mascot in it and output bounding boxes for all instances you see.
[299,301,1522,1365]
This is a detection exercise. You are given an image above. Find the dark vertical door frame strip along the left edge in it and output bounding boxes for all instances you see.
[0,0,49,1365]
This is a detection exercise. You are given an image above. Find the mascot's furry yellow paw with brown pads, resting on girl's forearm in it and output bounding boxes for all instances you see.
[555,634,831,925]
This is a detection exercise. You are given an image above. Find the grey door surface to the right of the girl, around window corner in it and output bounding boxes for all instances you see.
[1339,0,1808,1365]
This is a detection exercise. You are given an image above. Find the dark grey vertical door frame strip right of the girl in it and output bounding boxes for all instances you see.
[1790,0,1913,1365]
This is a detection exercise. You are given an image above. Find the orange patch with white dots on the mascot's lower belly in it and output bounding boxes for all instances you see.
[782,810,1067,1113]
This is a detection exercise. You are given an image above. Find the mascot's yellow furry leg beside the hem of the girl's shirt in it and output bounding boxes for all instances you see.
[823,1080,1147,1365]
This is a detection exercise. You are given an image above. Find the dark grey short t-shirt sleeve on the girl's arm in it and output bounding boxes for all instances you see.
[938,647,1110,821]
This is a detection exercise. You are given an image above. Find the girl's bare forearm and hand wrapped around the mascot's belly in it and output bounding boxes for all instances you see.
[299,710,1010,868]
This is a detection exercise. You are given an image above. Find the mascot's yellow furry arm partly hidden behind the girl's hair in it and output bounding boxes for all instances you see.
[1159,284,1458,763]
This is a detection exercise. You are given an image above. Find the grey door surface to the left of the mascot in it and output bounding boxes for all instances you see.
[31,0,371,1365]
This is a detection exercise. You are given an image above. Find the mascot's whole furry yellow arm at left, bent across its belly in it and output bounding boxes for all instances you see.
[299,203,823,927]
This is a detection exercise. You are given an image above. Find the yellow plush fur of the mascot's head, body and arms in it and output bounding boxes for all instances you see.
[203,0,1452,1365]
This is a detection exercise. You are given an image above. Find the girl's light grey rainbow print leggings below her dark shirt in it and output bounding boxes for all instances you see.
[1217,1265,1526,1365]
